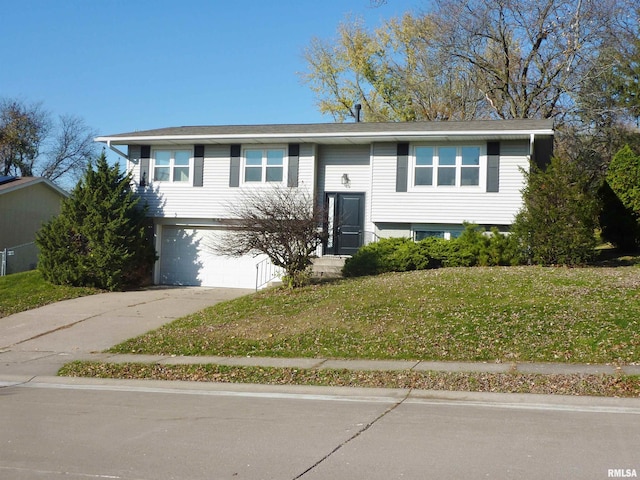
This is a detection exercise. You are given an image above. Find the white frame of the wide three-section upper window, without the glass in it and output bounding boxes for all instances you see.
[409,143,487,192]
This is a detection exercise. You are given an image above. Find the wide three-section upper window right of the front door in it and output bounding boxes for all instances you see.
[414,146,480,187]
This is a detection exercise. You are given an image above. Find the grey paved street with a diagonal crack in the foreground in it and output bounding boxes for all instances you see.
[0,377,640,480]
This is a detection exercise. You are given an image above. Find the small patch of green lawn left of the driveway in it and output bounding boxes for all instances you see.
[0,270,99,318]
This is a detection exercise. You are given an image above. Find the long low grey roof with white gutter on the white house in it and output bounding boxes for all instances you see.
[95,120,553,146]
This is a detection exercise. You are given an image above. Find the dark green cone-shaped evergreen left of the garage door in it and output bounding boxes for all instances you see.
[36,152,156,290]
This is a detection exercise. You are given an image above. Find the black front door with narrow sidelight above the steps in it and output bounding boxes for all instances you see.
[325,193,364,255]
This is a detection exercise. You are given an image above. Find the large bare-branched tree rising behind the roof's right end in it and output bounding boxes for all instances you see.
[432,0,637,119]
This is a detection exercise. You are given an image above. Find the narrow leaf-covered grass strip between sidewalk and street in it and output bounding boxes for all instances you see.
[58,362,640,397]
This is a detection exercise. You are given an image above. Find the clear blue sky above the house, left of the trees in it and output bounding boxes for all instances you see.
[0,0,423,142]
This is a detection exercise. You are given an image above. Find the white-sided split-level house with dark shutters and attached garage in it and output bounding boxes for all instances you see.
[96,120,554,288]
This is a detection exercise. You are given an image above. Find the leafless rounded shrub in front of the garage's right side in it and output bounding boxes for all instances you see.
[211,187,323,287]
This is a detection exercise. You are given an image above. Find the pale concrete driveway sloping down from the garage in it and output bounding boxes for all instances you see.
[0,287,253,375]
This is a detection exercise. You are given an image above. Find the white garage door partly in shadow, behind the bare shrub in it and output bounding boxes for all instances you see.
[160,226,265,288]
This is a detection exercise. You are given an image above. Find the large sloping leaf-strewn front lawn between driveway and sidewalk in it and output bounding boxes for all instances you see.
[111,266,640,363]
